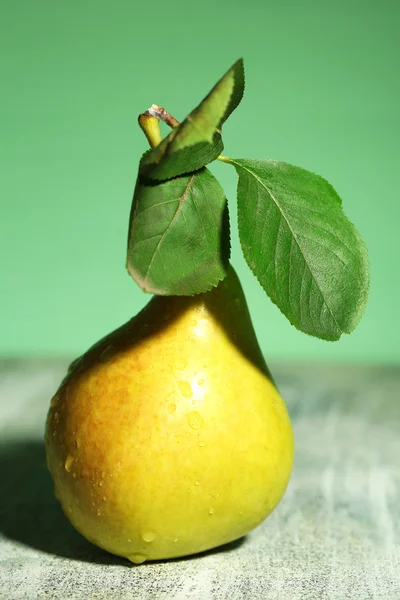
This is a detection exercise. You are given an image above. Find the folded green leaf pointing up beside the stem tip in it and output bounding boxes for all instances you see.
[139,59,244,180]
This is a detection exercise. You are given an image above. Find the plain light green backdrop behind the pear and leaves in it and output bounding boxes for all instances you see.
[0,0,400,362]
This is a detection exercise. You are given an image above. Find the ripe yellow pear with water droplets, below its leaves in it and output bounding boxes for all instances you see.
[46,267,293,563]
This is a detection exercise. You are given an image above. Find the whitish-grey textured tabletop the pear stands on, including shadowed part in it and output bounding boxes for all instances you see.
[0,361,400,600]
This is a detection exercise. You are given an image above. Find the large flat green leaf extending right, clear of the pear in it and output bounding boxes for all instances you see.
[225,159,369,340]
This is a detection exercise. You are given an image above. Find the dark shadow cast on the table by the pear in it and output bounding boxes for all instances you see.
[0,441,244,567]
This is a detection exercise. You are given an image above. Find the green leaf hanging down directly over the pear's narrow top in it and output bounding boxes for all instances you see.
[127,168,230,296]
